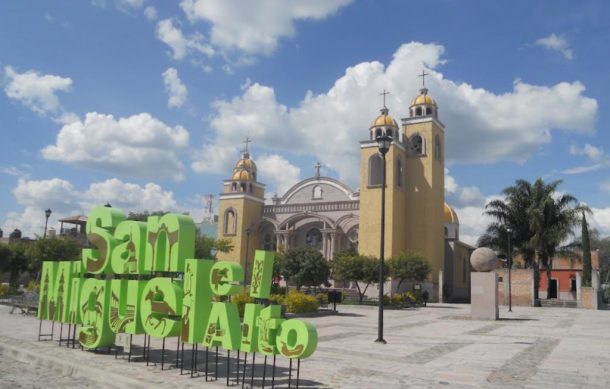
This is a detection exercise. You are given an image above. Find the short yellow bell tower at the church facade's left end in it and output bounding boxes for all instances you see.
[216,138,265,266]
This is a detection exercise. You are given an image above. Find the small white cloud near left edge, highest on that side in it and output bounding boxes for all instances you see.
[4,66,72,115]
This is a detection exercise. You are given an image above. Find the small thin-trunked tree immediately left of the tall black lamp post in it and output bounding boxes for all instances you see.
[332,250,378,304]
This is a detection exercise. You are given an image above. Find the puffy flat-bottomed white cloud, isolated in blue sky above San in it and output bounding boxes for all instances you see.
[42,112,189,180]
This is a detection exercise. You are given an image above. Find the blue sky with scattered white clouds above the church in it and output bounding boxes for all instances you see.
[0,0,610,243]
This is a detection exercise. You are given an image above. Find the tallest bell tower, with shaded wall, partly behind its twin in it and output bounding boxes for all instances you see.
[401,73,445,298]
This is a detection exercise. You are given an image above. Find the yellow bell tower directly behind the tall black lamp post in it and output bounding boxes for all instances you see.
[358,91,407,259]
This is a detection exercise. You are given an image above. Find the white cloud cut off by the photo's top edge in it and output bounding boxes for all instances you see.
[180,0,351,54]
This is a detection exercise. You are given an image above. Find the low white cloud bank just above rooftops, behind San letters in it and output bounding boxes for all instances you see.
[2,178,184,237]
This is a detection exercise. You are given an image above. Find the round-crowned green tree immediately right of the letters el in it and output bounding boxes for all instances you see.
[282,247,330,290]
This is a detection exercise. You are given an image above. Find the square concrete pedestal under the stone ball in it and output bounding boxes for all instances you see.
[470,272,499,320]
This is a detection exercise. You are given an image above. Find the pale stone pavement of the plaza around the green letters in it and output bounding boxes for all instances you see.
[0,304,610,389]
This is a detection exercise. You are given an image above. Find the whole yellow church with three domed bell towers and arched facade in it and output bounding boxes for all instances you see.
[218,81,474,301]
